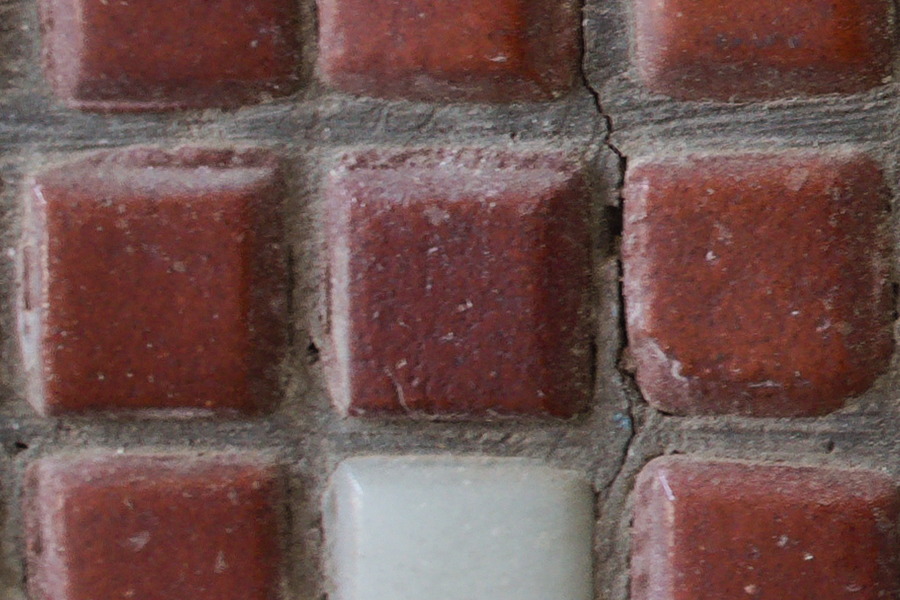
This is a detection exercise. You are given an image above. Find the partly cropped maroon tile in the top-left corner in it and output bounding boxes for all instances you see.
[40,0,298,111]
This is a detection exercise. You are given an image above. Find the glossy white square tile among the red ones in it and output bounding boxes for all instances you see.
[324,456,594,600]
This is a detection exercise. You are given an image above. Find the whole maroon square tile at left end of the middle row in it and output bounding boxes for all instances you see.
[19,149,287,414]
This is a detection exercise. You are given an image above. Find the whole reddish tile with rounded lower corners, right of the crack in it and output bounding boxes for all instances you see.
[623,154,893,416]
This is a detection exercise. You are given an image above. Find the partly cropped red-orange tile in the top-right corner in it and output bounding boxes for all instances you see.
[634,0,894,100]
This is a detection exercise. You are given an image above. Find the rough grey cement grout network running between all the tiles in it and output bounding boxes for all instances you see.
[2,3,898,598]
